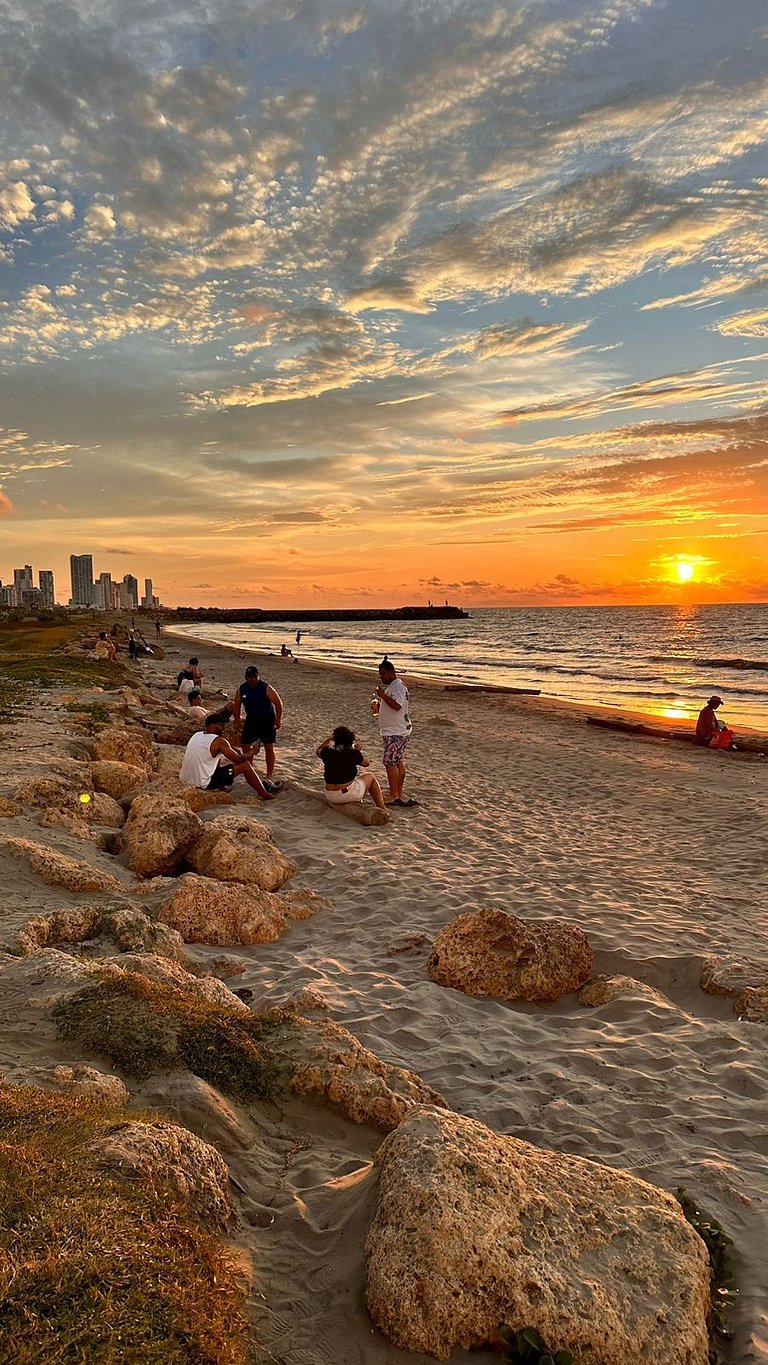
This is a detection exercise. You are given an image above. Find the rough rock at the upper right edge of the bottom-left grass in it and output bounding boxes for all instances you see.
[91,1122,235,1229]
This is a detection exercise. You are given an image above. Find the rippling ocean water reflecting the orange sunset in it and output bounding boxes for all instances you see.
[173,603,768,732]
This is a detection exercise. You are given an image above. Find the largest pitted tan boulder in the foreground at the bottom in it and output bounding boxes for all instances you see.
[366,1108,709,1365]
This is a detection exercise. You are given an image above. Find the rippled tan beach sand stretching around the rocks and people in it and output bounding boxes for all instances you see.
[0,633,768,1365]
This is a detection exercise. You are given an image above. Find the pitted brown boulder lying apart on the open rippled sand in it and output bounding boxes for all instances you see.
[427,910,595,1001]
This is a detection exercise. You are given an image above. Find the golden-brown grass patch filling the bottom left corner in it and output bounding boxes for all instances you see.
[0,1087,248,1365]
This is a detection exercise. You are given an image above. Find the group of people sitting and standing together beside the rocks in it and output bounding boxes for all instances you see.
[177,657,417,809]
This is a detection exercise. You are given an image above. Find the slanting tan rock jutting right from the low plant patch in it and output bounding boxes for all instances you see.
[276,1016,446,1133]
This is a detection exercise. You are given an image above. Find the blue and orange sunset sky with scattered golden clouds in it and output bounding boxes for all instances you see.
[0,0,768,607]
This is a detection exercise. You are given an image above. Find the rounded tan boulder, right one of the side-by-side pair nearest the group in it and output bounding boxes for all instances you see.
[186,815,296,891]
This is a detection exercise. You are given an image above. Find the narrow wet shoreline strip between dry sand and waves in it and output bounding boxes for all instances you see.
[162,627,768,743]
